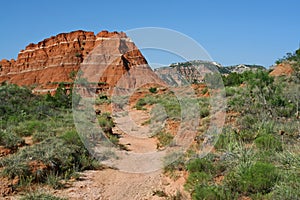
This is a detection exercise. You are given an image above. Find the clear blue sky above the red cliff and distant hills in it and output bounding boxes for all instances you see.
[0,0,300,67]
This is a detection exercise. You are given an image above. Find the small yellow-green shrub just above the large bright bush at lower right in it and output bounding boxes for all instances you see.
[254,134,282,151]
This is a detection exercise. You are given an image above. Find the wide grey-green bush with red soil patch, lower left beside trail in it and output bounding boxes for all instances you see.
[1,134,94,182]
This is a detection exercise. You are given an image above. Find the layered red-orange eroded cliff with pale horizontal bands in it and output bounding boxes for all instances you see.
[0,30,162,93]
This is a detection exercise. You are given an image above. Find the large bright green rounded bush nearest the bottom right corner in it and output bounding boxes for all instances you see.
[226,162,279,195]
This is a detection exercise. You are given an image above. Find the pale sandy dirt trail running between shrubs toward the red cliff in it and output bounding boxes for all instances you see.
[55,105,189,200]
